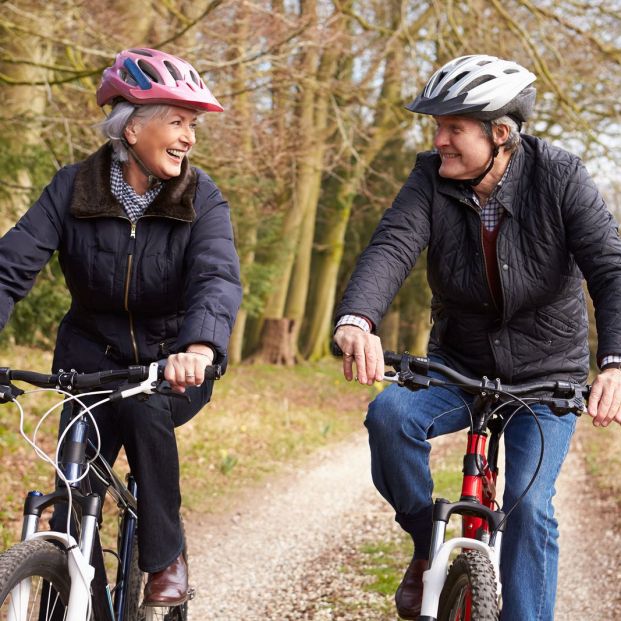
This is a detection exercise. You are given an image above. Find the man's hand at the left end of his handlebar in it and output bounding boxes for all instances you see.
[334,325,384,385]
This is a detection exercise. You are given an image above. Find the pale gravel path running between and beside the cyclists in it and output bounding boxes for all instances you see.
[186,434,621,621]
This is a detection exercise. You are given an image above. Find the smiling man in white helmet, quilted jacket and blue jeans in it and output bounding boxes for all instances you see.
[334,55,621,621]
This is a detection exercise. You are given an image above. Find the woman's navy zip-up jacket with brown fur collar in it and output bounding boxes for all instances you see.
[0,145,241,371]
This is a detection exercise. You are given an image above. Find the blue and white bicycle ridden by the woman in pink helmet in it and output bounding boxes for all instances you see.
[0,361,220,621]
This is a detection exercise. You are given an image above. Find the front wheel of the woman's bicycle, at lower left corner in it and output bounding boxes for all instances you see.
[0,539,71,621]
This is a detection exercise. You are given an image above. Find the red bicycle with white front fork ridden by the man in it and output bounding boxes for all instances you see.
[384,352,589,621]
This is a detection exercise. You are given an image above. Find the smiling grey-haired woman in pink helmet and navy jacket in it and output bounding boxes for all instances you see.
[0,49,241,606]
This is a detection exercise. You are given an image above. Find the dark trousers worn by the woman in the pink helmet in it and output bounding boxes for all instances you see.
[52,382,213,573]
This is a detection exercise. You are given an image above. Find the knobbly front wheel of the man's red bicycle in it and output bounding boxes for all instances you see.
[438,550,498,621]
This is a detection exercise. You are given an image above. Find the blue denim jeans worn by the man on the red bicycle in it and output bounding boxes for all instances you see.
[365,385,576,621]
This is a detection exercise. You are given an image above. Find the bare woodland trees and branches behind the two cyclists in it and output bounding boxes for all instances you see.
[0,0,621,364]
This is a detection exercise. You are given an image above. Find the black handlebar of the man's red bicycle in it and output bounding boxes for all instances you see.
[384,351,591,414]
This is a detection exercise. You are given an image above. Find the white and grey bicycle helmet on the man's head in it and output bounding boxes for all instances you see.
[406,54,537,125]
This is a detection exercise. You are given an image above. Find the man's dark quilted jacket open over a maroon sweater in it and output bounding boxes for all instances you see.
[336,135,621,382]
